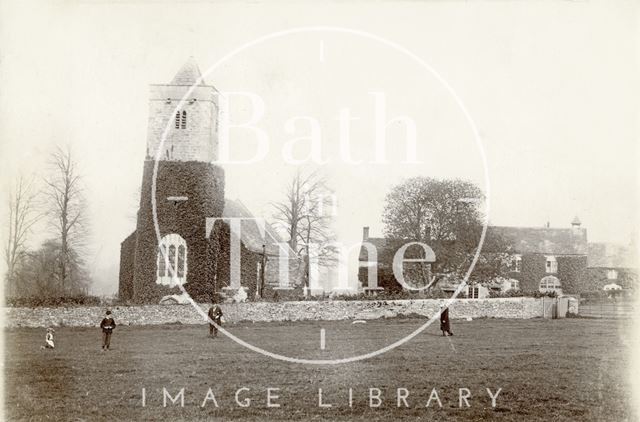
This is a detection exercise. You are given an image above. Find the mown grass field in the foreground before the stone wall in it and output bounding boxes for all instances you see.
[4,315,637,421]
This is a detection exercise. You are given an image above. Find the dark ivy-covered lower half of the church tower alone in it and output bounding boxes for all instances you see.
[132,160,224,303]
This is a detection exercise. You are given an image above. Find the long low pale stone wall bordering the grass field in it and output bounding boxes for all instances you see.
[2,297,577,328]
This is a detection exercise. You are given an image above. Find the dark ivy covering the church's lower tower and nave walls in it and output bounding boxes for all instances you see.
[119,160,288,303]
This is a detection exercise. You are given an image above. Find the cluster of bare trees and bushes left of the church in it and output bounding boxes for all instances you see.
[4,147,90,298]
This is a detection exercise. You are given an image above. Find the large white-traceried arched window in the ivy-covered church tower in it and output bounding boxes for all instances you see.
[156,233,187,286]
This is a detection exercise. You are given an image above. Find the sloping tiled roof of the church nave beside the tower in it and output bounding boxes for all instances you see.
[222,199,296,258]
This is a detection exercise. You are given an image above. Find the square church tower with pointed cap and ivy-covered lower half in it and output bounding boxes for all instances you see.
[120,58,224,303]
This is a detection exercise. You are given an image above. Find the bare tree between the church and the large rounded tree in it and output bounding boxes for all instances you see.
[273,171,336,284]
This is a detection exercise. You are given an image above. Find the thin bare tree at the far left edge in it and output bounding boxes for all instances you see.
[4,175,41,296]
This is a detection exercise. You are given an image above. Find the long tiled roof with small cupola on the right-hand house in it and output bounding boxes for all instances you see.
[487,226,587,255]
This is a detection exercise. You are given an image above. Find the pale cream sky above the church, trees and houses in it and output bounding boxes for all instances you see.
[0,1,640,294]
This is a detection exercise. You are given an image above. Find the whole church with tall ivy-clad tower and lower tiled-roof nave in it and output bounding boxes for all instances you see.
[118,58,304,303]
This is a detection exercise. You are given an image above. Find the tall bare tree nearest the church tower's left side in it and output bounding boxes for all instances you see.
[45,147,86,293]
